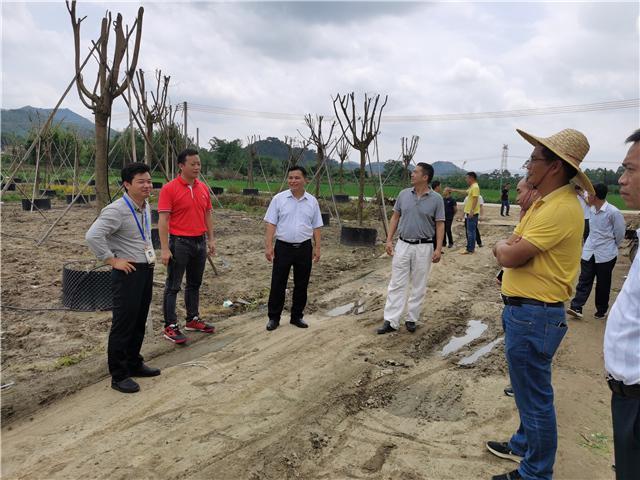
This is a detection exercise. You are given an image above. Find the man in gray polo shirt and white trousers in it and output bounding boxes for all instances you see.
[378,162,445,334]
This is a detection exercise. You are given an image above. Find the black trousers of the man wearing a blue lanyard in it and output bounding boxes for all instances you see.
[107,263,153,382]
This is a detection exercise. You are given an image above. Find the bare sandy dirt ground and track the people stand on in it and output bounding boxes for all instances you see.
[2,197,629,479]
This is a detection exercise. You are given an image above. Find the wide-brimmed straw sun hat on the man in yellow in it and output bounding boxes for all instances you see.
[516,128,595,195]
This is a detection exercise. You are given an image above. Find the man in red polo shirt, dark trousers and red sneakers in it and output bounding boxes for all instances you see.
[158,149,216,343]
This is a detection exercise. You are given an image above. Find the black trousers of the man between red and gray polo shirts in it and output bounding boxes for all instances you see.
[268,240,313,322]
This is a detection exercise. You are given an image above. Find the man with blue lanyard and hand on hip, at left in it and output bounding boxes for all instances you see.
[85,163,160,393]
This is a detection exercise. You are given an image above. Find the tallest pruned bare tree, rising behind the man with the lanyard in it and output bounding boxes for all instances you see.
[66,0,144,209]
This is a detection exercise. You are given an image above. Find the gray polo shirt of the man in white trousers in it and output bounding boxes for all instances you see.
[393,188,444,239]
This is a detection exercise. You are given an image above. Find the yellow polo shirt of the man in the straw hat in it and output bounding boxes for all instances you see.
[502,185,584,303]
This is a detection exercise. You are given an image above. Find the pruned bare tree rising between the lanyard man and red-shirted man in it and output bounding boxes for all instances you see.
[133,69,171,165]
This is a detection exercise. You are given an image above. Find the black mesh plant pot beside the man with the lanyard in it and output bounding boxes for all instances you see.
[62,261,113,312]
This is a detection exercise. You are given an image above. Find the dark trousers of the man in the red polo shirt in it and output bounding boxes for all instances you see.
[162,235,207,327]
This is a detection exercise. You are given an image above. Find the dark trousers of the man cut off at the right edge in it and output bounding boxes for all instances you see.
[611,393,640,480]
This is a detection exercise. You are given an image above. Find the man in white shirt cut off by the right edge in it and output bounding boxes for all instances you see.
[604,129,640,480]
